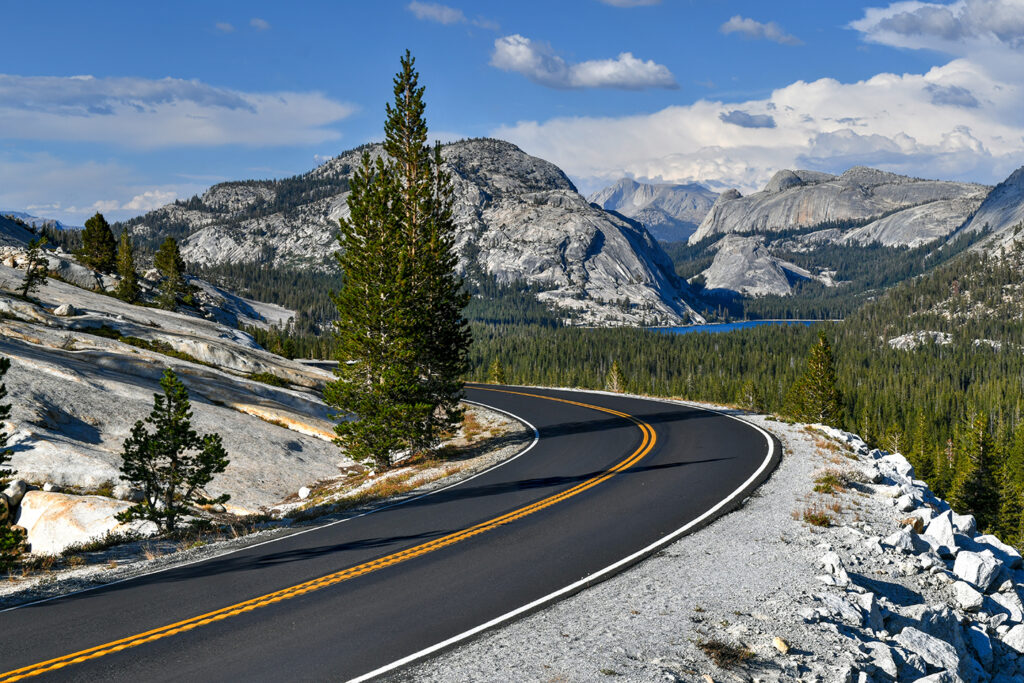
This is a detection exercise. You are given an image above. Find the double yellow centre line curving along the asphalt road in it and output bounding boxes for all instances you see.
[0,387,657,683]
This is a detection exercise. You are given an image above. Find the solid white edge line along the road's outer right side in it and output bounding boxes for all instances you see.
[348,387,775,683]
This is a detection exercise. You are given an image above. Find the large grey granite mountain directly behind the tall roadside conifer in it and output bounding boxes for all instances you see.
[128,138,700,325]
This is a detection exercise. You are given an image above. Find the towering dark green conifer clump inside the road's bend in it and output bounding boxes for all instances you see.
[324,52,469,468]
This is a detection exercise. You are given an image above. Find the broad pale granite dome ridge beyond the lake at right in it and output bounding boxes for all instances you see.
[689,166,989,247]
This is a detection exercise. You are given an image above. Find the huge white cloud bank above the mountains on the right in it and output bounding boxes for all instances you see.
[494,53,1024,193]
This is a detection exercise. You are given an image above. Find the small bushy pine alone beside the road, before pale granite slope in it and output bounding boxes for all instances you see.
[118,368,228,531]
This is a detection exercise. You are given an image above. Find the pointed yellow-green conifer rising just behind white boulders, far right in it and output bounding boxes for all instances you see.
[949,413,999,530]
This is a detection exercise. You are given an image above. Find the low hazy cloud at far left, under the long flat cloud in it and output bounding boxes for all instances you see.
[0,154,208,225]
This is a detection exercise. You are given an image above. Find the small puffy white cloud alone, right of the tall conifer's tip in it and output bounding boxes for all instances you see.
[490,34,679,90]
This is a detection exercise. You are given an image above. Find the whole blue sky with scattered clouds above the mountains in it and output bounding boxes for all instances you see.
[0,0,1024,224]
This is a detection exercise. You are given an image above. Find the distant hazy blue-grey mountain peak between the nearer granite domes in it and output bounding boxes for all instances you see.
[588,178,718,242]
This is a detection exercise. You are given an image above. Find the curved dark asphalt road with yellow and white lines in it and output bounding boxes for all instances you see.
[0,385,780,683]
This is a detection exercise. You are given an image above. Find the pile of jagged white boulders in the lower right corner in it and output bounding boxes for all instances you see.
[800,427,1024,683]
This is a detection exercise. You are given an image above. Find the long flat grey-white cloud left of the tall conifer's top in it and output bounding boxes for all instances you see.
[0,75,354,148]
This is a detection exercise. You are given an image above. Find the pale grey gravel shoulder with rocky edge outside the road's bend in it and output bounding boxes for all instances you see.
[397,395,1024,683]
